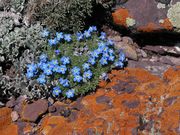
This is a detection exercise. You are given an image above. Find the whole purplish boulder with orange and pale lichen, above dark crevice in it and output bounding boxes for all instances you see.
[112,0,180,32]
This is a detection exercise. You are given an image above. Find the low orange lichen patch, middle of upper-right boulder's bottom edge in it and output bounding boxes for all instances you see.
[137,22,160,32]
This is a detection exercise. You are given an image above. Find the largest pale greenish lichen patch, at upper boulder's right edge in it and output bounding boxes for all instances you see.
[167,2,180,29]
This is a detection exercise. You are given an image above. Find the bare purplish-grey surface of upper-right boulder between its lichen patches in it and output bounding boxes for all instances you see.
[123,0,167,29]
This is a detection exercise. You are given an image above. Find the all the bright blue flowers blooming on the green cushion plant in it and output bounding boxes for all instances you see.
[26,26,125,98]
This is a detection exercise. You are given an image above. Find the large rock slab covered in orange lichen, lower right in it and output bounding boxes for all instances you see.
[38,66,180,135]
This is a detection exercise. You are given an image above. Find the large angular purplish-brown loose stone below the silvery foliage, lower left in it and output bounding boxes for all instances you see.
[22,99,48,122]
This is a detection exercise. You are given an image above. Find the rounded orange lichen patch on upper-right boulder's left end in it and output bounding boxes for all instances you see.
[112,8,131,27]
